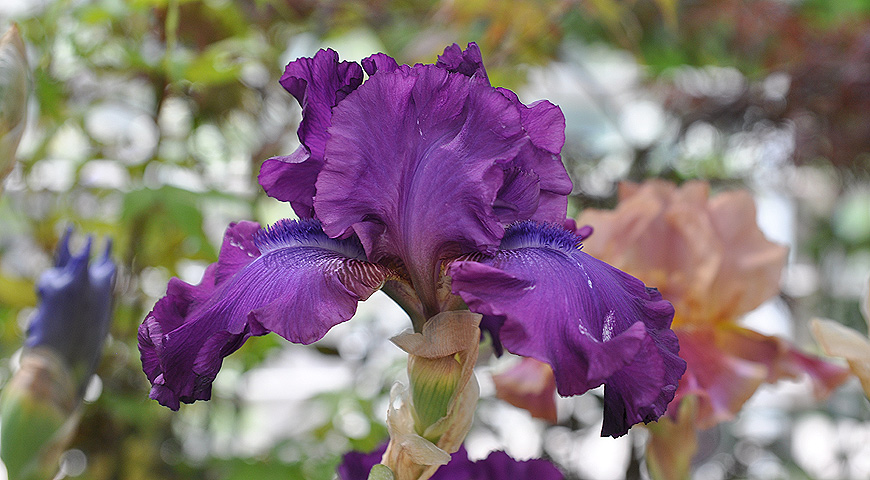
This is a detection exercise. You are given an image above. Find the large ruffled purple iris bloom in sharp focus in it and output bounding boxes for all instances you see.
[139,44,685,435]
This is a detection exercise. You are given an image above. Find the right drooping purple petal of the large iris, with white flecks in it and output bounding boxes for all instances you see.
[448,222,686,436]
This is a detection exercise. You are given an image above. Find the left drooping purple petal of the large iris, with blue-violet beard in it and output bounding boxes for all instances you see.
[139,220,389,409]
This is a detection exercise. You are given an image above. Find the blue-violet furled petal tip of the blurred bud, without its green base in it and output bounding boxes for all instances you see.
[25,229,116,396]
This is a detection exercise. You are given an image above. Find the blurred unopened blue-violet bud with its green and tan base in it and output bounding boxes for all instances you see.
[0,231,115,480]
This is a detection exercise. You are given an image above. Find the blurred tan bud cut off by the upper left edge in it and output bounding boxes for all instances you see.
[0,25,30,186]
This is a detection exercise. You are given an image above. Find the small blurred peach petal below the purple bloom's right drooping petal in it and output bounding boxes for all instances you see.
[492,357,556,423]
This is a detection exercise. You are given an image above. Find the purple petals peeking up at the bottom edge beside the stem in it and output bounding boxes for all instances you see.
[337,444,565,480]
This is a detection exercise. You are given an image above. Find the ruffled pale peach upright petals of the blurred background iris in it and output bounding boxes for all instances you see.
[577,180,788,327]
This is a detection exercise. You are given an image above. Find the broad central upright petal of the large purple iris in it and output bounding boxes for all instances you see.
[314,65,564,314]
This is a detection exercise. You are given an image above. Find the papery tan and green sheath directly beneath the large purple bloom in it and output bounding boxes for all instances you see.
[382,310,480,480]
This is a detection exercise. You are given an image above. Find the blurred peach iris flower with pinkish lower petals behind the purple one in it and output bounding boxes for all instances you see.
[499,180,848,465]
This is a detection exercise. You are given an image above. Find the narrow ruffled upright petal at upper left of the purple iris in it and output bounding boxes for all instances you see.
[259,49,363,218]
